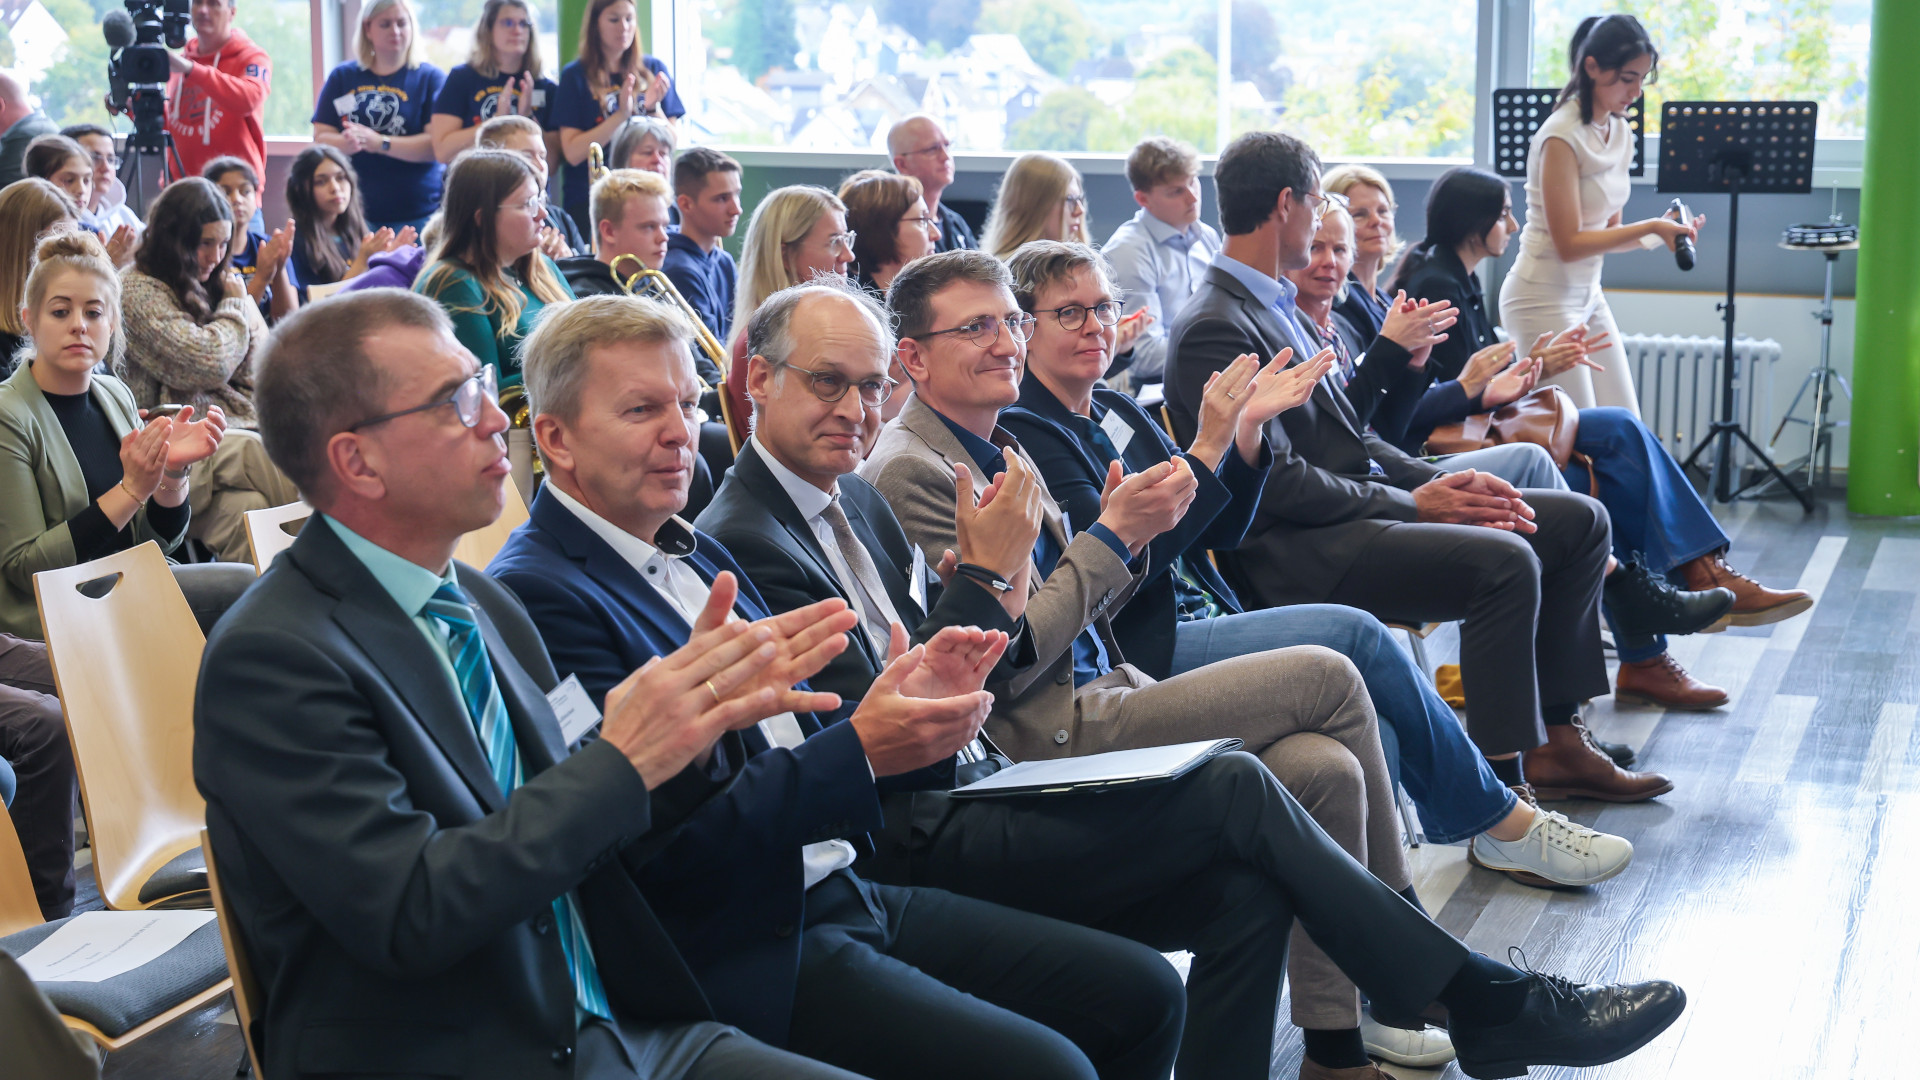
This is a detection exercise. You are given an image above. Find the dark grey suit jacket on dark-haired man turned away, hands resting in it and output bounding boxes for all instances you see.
[1165,267,1442,605]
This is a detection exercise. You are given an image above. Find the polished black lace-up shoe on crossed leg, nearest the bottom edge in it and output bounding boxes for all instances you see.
[1450,949,1686,1080]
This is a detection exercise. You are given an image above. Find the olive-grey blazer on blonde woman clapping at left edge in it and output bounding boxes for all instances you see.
[0,363,186,640]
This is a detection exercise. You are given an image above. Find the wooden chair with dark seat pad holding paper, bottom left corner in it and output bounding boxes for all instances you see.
[0,813,232,1053]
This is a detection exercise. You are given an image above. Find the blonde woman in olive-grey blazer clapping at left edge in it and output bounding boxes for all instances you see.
[0,229,227,638]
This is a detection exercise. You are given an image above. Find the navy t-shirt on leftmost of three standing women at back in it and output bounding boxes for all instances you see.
[313,60,447,227]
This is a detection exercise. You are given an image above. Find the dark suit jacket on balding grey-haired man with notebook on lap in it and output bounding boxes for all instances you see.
[695,434,1020,701]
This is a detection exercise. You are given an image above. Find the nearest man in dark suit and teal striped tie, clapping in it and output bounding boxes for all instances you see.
[194,288,929,1080]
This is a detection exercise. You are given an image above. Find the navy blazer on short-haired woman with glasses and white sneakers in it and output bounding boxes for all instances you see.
[1000,373,1273,678]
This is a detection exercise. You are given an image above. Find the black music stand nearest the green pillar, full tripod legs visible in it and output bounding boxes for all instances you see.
[1659,102,1820,513]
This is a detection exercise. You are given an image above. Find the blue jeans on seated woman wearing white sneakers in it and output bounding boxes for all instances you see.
[1173,603,1515,844]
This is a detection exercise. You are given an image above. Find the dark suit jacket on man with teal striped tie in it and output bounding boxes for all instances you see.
[194,517,714,1080]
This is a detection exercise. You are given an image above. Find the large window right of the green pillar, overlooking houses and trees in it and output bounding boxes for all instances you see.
[687,0,1475,156]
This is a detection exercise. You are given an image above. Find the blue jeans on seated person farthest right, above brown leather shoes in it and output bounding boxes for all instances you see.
[1565,407,1728,661]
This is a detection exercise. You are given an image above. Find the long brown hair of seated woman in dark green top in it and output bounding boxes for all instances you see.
[419,150,572,338]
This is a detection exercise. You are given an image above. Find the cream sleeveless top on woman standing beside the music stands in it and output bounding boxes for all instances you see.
[1513,100,1634,286]
